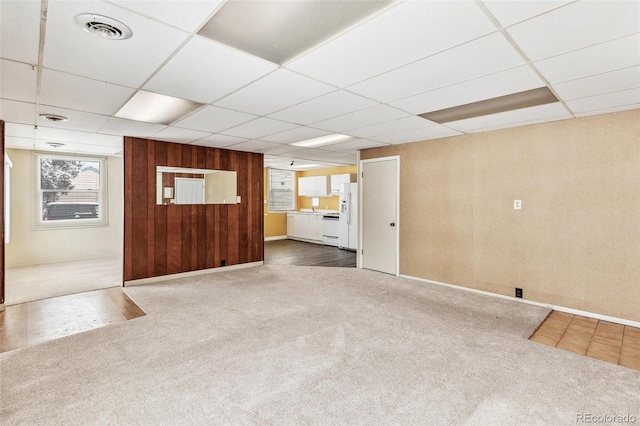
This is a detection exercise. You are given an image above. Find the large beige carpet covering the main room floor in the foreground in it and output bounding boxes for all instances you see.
[0,265,640,426]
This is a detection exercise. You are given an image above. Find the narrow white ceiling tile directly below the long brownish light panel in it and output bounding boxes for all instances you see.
[446,102,571,132]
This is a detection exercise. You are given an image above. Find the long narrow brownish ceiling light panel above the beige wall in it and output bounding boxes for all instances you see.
[420,87,558,124]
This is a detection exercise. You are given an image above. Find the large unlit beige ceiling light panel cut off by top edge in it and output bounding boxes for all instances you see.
[198,0,395,65]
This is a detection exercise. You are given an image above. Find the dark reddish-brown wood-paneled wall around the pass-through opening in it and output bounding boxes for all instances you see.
[124,137,264,281]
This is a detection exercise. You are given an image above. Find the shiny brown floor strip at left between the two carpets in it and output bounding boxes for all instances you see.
[0,287,145,353]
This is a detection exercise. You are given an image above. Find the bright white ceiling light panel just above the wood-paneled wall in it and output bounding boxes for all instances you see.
[115,90,204,125]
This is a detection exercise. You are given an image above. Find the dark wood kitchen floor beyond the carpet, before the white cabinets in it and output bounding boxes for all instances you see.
[264,240,356,268]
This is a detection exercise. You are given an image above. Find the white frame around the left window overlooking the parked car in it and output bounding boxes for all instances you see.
[33,152,109,230]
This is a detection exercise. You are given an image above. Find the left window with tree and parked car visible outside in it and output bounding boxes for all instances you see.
[36,154,107,228]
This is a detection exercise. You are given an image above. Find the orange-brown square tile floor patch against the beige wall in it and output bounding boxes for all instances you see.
[530,311,640,370]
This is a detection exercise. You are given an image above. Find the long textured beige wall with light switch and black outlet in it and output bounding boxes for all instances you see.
[361,110,640,321]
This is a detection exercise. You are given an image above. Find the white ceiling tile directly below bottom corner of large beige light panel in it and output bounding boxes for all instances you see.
[216,69,335,115]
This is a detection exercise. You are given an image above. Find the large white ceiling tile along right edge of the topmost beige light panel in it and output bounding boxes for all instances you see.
[285,1,495,87]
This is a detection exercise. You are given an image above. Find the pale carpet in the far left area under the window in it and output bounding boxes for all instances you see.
[5,257,122,305]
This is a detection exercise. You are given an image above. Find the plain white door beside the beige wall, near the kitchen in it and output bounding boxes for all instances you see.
[361,158,399,275]
